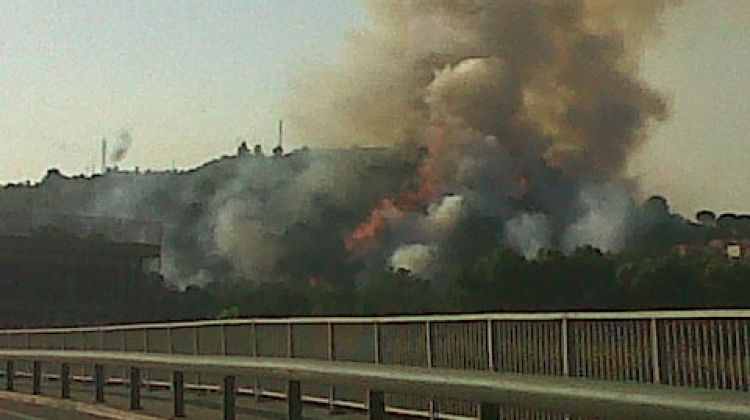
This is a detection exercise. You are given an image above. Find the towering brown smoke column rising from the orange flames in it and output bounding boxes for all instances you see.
[291,0,668,275]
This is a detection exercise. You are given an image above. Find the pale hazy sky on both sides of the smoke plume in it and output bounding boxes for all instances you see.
[0,0,750,214]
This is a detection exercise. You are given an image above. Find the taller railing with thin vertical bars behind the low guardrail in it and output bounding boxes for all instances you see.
[0,310,750,419]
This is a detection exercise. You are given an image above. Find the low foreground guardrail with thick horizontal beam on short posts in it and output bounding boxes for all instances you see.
[0,350,750,420]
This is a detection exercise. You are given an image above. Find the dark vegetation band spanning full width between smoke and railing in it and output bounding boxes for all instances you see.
[0,198,750,327]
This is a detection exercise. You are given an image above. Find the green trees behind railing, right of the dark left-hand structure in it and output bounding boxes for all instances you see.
[176,197,750,318]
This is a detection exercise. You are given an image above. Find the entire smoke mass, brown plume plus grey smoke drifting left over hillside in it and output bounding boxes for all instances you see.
[5,0,680,284]
